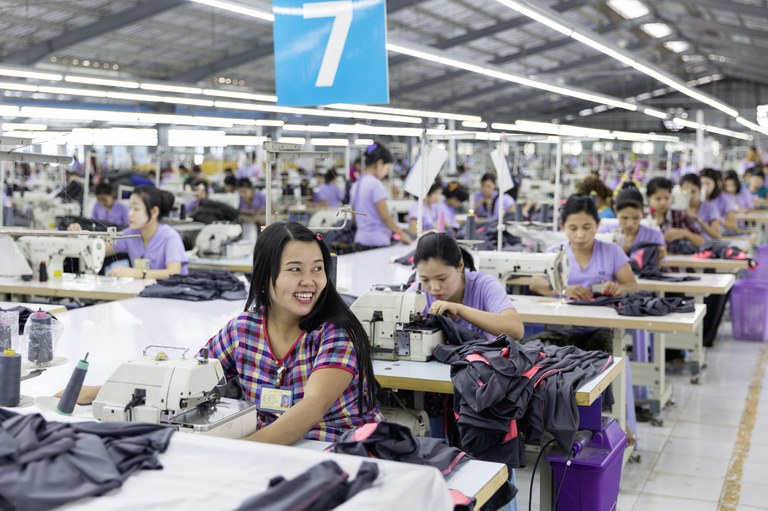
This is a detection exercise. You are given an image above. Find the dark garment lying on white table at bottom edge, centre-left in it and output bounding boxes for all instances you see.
[236,460,379,511]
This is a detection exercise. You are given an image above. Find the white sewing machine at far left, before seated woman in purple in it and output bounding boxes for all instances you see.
[16,235,106,278]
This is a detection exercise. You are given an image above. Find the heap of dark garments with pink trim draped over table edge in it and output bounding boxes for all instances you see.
[434,335,613,468]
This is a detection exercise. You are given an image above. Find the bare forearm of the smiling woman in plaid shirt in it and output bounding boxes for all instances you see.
[245,367,352,445]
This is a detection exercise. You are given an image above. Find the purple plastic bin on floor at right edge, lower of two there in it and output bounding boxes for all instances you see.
[731,279,768,342]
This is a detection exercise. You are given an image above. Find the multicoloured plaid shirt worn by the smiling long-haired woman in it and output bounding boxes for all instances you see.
[206,310,383,442]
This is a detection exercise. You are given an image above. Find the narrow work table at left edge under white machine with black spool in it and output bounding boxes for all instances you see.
[0,273,155,300]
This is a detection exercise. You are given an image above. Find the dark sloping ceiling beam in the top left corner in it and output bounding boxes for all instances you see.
[3,0,188,66]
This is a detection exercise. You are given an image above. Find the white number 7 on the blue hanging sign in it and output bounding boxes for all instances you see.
[302,0,354,87]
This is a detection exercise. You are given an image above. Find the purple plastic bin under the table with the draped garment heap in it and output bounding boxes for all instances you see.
[547,417,627,511]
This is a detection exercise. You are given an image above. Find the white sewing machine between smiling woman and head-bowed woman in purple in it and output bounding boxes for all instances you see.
[350,290,444,362]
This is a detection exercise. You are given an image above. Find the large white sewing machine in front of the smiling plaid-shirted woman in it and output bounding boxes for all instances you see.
[93,346,258,438]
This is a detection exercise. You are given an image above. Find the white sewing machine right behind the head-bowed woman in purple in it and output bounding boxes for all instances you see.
[472,247,570,294]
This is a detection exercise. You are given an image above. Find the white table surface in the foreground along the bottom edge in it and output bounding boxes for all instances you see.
[59,433,452,511]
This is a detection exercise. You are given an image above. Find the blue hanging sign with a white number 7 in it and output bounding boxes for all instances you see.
[272,0,389,106]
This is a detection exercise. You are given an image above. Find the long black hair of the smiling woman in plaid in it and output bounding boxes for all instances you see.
[245,222,376,413]
